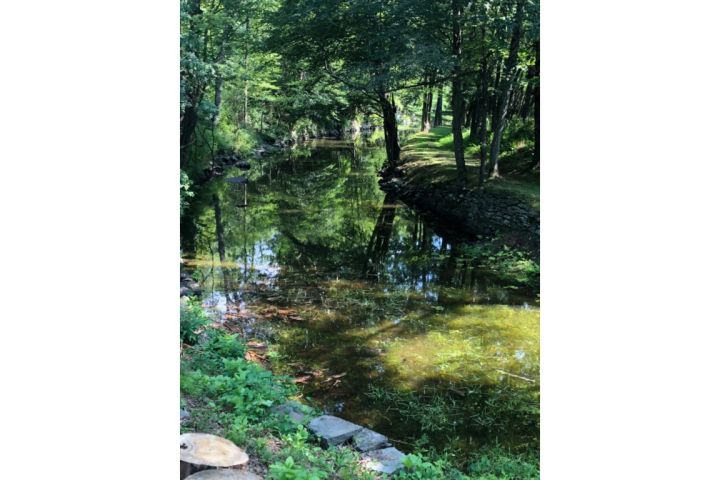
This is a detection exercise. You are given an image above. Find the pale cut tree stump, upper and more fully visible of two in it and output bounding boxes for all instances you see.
[180,433,249,480]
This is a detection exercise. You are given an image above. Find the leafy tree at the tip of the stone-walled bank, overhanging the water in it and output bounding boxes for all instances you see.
[273,0,442,166]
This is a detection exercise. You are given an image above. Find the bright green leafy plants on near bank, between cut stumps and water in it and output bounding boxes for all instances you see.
[180,329,372,480]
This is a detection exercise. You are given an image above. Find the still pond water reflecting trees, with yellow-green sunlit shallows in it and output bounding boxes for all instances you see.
[183,141,540,451]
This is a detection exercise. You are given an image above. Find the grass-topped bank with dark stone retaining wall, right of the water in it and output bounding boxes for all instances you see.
[380,126,540,253]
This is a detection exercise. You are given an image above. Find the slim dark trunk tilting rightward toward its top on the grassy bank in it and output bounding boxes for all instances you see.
[490,0,525,177]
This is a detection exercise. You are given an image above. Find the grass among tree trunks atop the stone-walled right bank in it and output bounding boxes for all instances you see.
[402,122,540,209]
